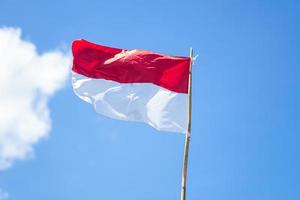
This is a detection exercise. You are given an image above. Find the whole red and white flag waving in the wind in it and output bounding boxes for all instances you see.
[72,39,191,133]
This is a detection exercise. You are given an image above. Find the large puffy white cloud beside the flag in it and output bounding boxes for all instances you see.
[0,28,70,170]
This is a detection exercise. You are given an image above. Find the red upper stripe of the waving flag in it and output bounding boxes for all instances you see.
[72,39,190,93]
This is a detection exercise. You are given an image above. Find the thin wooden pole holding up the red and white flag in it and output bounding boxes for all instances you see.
[181,48,193,200]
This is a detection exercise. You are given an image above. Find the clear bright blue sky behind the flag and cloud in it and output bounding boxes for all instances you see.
[0,0,300,200]
